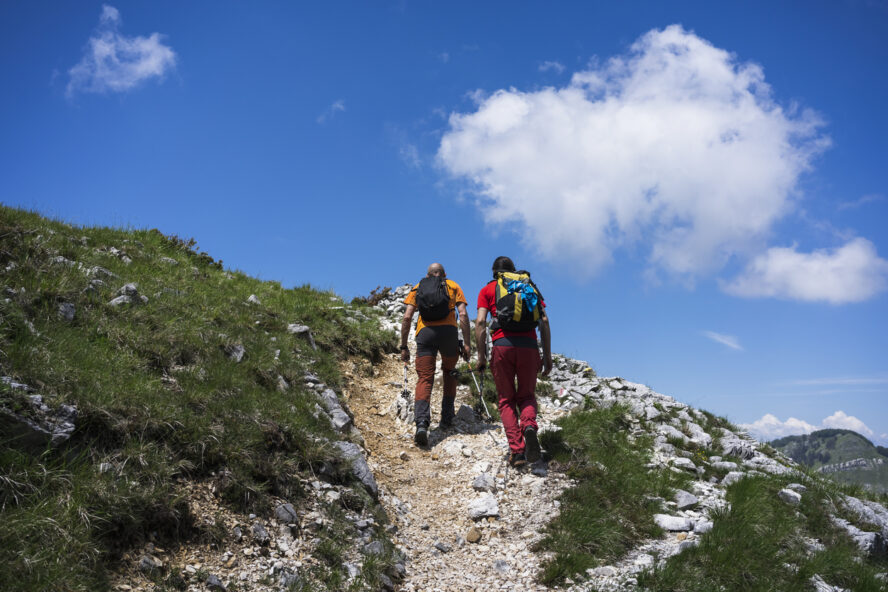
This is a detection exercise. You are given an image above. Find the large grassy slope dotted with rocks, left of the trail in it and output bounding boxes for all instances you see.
[0,207,395,591]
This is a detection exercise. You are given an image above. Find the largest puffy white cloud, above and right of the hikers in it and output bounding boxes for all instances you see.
[438,25,829,276]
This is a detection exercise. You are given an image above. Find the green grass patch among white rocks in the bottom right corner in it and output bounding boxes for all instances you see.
[639,477,888,592]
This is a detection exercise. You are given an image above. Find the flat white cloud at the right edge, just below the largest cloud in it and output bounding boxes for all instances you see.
[722,238,888,304]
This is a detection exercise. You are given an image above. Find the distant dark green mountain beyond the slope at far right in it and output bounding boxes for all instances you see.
[770,429,888,492]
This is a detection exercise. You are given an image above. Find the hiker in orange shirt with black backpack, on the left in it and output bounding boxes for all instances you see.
[401,263,471,446]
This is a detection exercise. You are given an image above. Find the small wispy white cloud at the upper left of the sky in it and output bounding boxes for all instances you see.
[66,4,176,97]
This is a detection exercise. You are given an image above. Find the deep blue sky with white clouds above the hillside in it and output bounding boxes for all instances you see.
[0,0,888,444]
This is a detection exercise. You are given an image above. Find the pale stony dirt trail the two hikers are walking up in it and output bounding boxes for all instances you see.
[344,350,570,591]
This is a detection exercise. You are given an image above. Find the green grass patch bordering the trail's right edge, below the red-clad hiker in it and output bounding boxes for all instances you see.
[538,406,689,585]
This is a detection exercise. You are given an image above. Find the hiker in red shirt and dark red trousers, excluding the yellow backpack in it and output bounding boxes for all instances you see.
[475,257,552,466]
